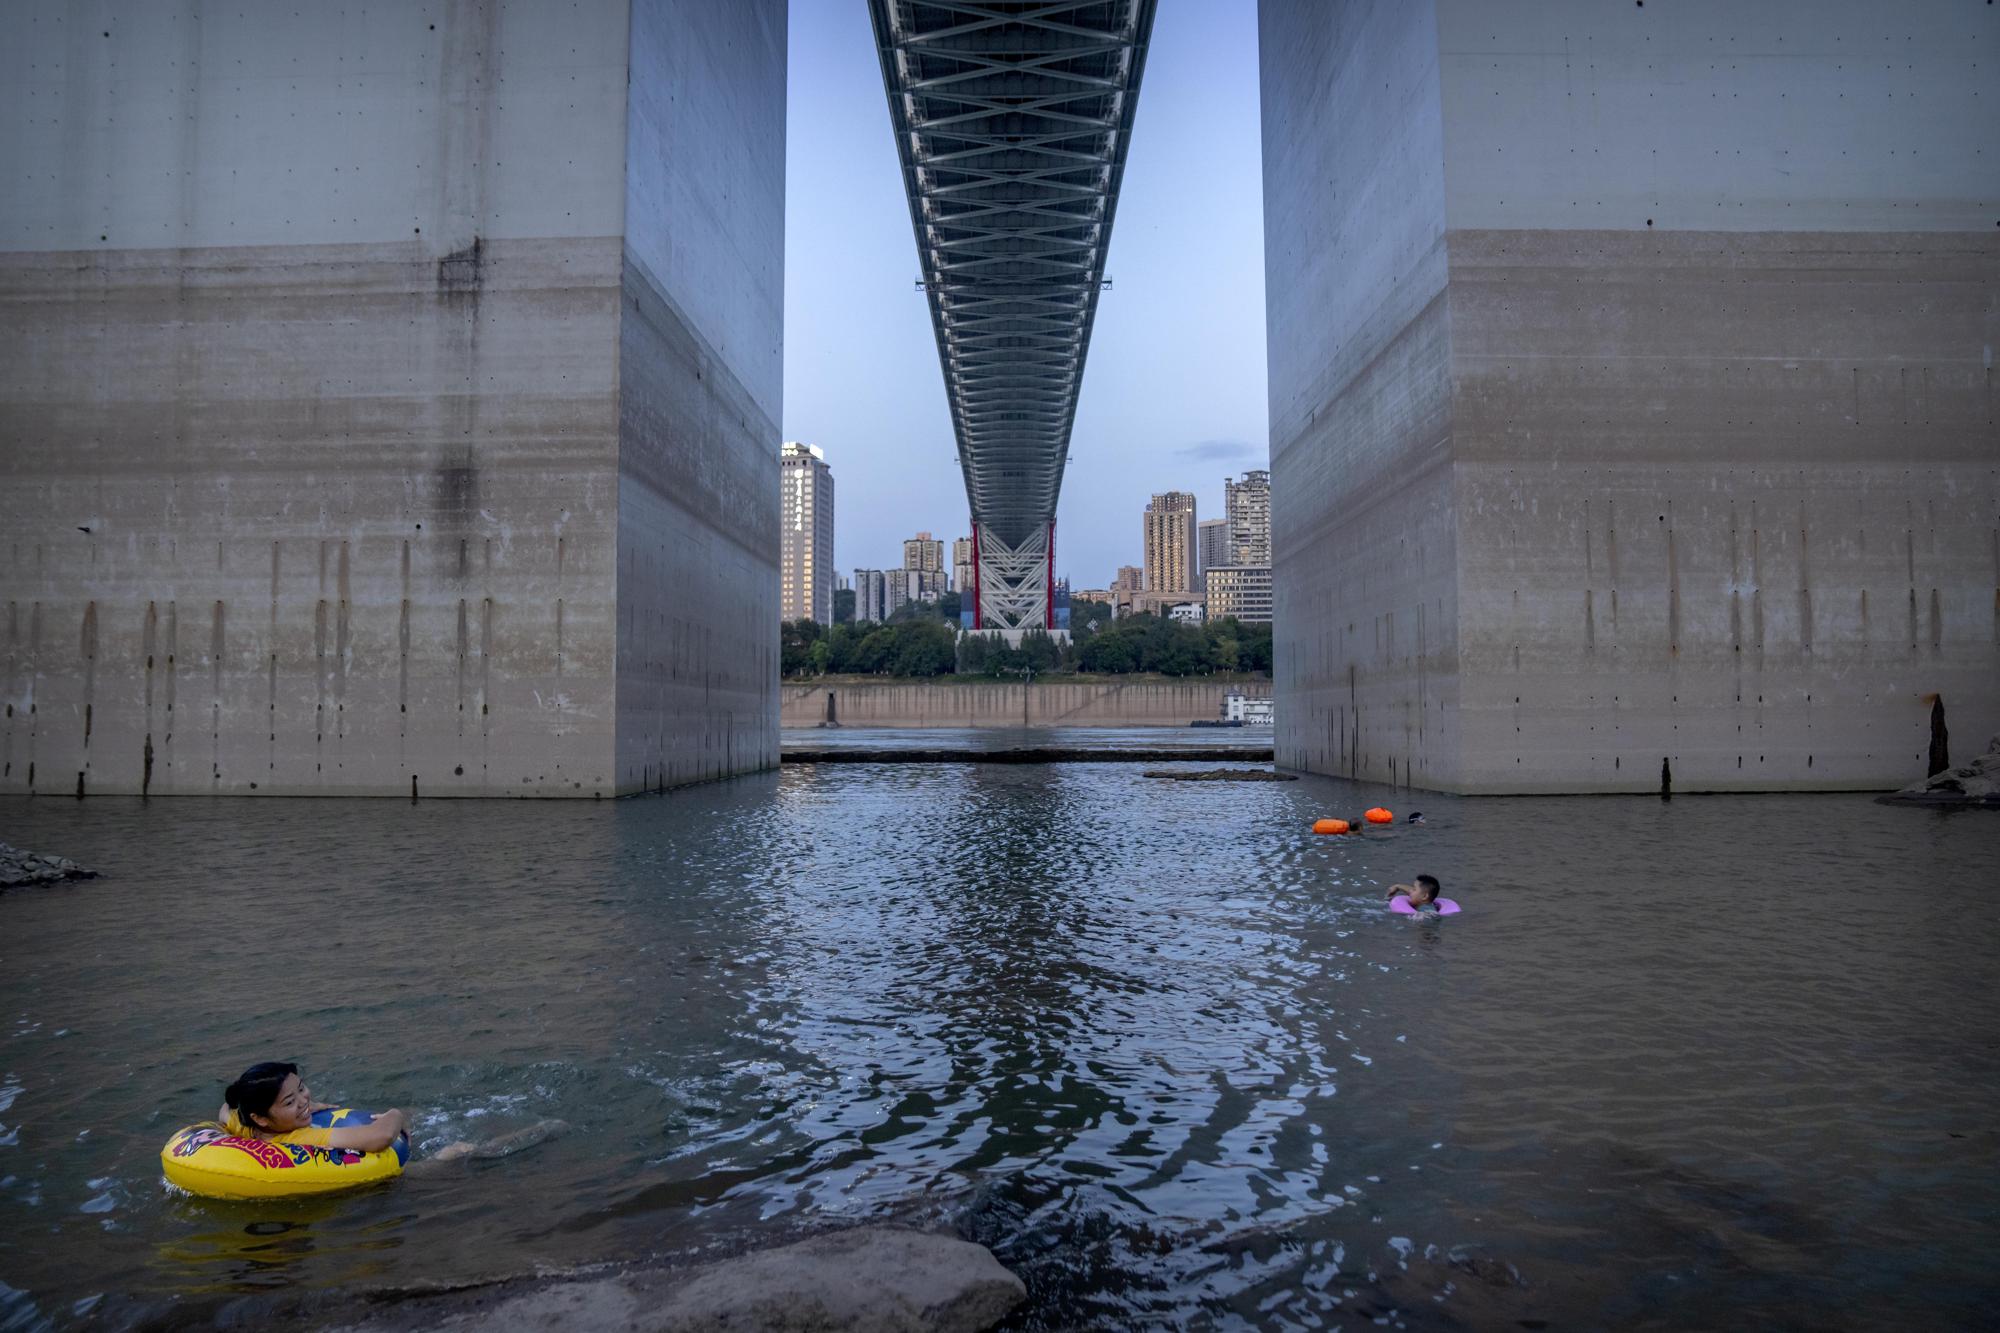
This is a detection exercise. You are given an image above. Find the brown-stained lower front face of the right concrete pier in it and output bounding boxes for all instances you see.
[1452,228,2000,791]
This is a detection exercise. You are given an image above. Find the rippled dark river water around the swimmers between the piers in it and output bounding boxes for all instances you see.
[0,765,2000,1329]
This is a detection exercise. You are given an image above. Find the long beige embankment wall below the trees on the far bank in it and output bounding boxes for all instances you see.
[782,679,1270,727]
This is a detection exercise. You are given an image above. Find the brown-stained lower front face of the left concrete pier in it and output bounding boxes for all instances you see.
[0,240,618,795]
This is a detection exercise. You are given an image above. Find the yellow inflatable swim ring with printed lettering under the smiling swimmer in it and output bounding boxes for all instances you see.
[160,1107,410,1199]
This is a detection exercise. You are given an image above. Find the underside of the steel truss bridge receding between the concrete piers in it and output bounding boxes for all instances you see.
[868,0,1156,630]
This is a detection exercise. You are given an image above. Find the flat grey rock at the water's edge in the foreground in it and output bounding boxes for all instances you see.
[336,1227,1028,1333]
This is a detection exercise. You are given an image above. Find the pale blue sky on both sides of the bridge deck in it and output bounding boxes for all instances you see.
[784,0,1268,588]
